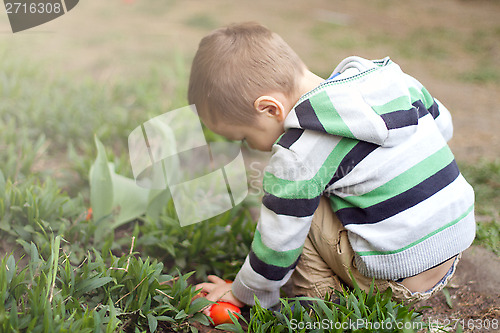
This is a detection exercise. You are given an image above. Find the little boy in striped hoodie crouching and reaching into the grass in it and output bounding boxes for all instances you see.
[188,23,475,307]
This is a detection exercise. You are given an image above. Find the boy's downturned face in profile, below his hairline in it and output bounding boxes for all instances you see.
[202,109,285,151]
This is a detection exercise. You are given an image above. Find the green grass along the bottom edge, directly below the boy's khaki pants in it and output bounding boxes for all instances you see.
[218,278,425,333]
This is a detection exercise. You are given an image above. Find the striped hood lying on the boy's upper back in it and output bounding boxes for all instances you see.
[285,56,433,146]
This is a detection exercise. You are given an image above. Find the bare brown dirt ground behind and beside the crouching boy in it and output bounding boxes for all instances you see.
[0,0,500,332]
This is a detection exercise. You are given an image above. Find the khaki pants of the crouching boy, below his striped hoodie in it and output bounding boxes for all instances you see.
[292,197,458,302]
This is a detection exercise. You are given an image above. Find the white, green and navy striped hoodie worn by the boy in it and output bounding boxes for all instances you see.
[233,57,475,307]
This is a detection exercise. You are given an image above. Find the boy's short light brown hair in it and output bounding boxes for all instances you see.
[188,22,306,124]
